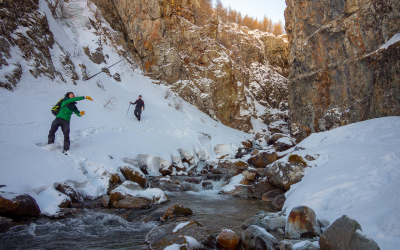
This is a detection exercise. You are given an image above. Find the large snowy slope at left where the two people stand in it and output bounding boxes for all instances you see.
[0,1,251,215]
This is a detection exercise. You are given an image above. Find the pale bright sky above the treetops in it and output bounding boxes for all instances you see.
[214,0,286,23]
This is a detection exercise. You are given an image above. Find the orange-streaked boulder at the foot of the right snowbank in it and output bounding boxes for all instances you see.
[285,206,321,239]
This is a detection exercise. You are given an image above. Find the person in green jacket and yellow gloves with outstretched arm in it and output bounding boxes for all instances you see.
[48,92,93,154]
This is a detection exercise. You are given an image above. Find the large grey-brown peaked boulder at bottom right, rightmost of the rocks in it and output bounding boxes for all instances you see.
[319,215,380,250]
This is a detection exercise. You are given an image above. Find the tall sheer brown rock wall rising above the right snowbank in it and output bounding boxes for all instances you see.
[285,0,400,139]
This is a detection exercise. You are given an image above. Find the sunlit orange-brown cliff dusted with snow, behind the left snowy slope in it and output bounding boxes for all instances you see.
[95,0,288,131]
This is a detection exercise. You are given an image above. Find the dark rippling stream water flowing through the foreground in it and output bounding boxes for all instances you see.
[0,191,274,249]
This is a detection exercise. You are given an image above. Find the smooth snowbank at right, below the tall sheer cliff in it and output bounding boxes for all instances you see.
[284,117,400,250]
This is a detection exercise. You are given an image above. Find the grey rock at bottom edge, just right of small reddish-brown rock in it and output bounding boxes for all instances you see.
[242,225,279,250]
